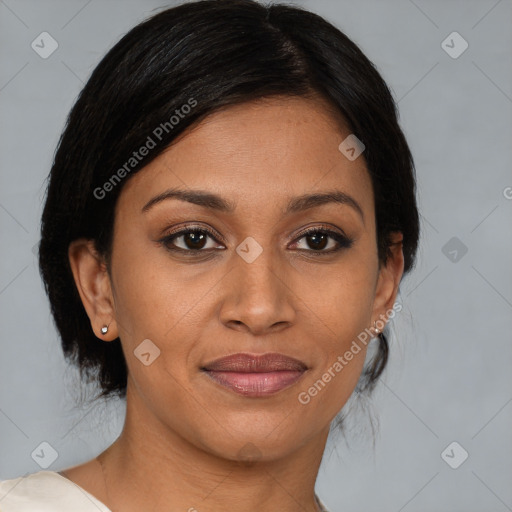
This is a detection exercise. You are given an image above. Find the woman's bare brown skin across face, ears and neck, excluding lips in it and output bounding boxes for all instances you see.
[63,98,403,512]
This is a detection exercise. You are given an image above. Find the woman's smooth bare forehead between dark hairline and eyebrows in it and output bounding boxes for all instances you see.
[116,97,373,220]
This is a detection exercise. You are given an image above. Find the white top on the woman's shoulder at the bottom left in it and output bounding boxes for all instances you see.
[0,471,329,512]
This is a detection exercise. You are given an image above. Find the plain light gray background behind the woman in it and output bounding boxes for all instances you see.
[0,0,512,512]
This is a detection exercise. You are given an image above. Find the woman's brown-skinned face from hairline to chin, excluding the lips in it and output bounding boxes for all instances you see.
[70,94,403,459]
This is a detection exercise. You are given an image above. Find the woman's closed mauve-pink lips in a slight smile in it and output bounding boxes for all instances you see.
[201,353,308,397]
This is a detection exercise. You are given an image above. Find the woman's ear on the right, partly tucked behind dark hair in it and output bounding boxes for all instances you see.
[372,231,404,331]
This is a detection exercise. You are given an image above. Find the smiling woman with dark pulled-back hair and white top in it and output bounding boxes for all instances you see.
[0,0,419,512]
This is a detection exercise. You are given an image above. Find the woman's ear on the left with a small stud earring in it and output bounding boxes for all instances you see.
[68,238,118,341]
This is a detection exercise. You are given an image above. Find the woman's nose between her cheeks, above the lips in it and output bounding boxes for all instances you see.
[220,250,297,336]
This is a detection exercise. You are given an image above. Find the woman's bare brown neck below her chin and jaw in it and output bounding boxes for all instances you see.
[98,378,329,512]
